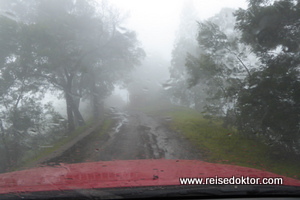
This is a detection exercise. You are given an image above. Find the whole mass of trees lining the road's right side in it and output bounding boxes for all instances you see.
[170,0,300,154]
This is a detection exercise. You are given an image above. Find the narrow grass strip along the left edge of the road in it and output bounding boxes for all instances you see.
[16,118,112,171]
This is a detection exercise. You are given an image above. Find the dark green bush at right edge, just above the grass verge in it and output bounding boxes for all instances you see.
[239,56,300,148]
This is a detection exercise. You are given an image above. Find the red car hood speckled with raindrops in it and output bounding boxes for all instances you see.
[0,159,300,194]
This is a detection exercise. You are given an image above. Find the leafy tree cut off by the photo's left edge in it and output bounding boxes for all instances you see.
[0,12,57,171]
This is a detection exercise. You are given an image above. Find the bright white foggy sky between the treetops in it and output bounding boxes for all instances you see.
[109,0,247,59]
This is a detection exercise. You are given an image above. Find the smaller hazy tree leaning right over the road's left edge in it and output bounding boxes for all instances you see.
[82,27,145,118]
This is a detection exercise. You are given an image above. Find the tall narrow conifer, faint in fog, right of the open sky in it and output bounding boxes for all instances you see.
[166,0,197,106]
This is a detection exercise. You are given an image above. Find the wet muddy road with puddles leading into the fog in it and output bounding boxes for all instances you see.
[46,111,202,163]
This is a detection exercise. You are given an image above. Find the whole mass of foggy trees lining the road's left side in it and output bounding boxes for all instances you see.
[0,0,144,171]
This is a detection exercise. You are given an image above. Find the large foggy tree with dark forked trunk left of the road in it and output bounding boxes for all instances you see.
[33,1,116,131]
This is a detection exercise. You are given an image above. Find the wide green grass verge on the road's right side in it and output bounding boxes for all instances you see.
[146,106,300,179]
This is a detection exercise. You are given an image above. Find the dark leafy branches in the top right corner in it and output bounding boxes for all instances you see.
[235,0,300,53]
